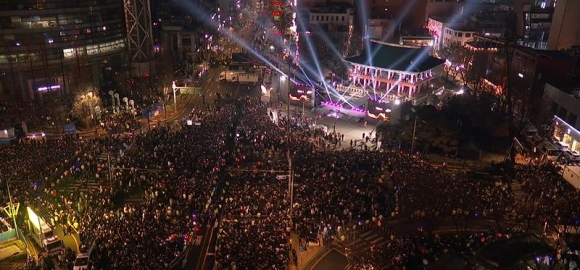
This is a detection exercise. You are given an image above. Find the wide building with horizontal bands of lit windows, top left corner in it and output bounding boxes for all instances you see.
[0,0,126,99]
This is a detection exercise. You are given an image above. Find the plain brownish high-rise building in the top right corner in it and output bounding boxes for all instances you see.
[548,0,580,50]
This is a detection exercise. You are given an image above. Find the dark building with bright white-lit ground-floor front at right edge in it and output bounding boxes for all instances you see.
[544,84,580,152]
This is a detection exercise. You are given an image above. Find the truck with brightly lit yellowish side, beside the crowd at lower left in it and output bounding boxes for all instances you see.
[26,207,64,255]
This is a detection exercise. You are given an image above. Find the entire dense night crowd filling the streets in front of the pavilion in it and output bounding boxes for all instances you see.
[0,93,579,269]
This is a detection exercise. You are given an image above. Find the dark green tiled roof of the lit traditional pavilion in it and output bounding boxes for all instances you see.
[345,41,445,72]
